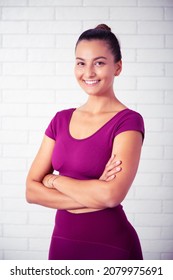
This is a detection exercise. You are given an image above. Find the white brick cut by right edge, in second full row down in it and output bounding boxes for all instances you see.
[138,21,173,35]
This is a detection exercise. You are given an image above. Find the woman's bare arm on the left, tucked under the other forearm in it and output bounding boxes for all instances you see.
[26,136,84,209]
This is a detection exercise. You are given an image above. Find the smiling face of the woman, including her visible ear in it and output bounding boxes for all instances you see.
[75,40,121,96]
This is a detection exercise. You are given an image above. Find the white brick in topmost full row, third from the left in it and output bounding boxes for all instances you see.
[110,7,163,21]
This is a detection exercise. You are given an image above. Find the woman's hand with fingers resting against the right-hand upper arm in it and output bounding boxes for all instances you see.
[99,155,122,182]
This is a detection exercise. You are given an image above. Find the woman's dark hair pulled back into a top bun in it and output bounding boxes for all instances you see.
[76,24,122,62]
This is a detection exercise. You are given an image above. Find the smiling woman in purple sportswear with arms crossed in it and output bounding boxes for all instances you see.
[26,24,144,260]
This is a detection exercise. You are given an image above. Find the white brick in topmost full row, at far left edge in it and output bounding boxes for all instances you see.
[2,7,54,20]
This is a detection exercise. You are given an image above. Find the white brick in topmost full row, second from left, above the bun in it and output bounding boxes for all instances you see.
[56,7,109,20]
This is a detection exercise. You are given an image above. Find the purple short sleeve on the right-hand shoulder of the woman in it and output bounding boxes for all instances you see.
[114,110,145,140]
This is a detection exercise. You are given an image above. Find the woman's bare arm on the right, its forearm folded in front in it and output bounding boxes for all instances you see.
[47,131,142,209]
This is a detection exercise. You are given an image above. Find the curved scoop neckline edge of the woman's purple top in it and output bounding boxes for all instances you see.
[68,108,130,141]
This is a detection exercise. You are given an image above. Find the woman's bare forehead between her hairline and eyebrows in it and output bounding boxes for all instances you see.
[76,40,112,59]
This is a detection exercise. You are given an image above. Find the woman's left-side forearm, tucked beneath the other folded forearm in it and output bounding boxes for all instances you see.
[26,180,85,210]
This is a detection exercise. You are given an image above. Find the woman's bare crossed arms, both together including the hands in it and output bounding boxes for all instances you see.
[26,131,142,210]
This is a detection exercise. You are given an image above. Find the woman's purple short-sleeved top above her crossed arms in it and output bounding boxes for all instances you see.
[45,108,144,180]
